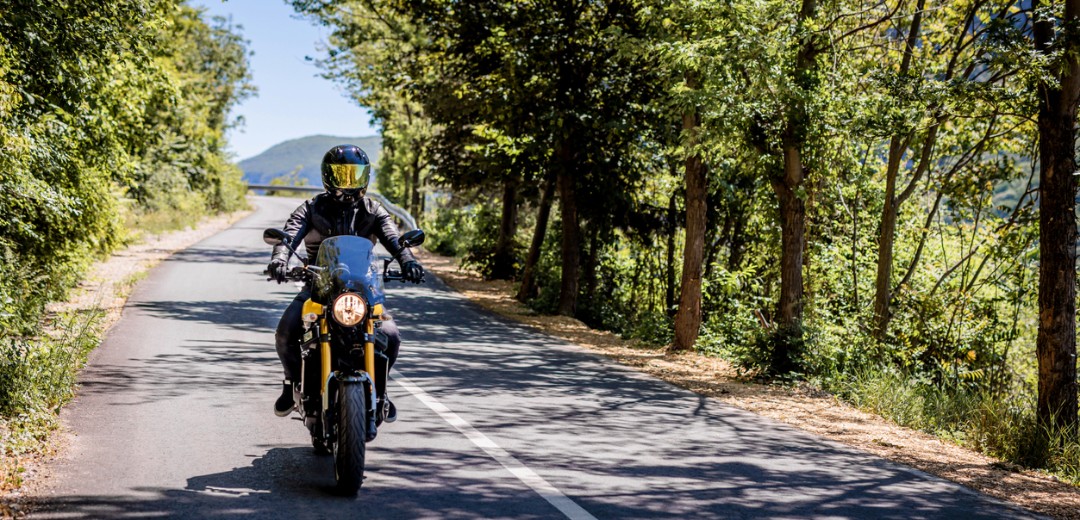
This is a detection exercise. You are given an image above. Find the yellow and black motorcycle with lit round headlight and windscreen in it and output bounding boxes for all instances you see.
[262,228,424,495]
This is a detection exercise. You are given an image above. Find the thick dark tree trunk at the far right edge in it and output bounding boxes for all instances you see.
[1032,0,1080,427]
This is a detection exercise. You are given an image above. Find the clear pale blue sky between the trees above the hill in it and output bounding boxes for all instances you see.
[189,0,378,160]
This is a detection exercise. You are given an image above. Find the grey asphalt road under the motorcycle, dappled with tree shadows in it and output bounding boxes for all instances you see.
[32,199,1032,519]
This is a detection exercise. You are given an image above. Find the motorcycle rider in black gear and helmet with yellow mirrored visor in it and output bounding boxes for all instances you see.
[267,145,423,423]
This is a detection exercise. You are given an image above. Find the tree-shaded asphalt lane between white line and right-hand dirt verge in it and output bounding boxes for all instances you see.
[373,278,1027,519]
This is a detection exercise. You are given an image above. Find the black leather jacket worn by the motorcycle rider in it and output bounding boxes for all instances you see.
[273,194,416,264]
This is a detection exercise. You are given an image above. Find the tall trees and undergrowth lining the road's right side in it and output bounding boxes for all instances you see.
[292,0,1080,483]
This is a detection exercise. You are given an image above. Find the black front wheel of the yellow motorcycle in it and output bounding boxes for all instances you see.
[334,385,367,495]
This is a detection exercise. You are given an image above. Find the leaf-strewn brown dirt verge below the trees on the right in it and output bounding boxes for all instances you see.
[420,252,1080,520]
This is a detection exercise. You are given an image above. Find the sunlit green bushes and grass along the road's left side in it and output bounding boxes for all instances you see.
[0,0,253,491]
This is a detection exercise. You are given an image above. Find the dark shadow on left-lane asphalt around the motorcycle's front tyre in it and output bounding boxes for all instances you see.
[33,448,558,520]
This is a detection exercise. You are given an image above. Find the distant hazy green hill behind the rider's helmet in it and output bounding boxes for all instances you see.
[239,135,382,186]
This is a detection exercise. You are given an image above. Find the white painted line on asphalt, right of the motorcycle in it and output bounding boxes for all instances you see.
[393,371,596,520]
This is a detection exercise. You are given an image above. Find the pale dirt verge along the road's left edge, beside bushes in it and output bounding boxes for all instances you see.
[0,205,251,518]
